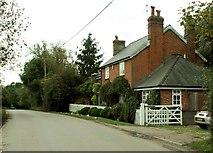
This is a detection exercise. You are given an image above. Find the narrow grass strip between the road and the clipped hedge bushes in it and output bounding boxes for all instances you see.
[59,113,134,126]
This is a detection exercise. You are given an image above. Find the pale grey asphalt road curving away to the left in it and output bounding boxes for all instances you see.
[0,110,169,151]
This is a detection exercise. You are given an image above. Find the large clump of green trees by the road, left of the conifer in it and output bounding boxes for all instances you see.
[21,42,82,111]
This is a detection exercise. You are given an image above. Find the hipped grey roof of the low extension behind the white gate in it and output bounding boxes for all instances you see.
[133,56,202,89]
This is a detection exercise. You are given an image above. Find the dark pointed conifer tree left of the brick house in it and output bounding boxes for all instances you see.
[75,33,103,77]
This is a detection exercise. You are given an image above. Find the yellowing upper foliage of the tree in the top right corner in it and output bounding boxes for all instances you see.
[180,1,213,65]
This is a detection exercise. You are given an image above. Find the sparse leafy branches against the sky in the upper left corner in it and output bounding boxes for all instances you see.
[0,0,29,67]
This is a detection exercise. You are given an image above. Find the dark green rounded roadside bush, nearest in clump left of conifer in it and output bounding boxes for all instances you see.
[42,68,81,111]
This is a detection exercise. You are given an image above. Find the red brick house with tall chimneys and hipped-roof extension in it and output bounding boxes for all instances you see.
[101,7,206,111]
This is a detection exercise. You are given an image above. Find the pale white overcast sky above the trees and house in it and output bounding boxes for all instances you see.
[1,0,210,84]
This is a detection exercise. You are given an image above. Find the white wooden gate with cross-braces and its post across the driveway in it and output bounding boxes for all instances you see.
[135,103,183,125]
